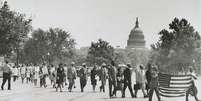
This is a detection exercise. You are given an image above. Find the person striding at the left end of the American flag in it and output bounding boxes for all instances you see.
[149,66,161,101]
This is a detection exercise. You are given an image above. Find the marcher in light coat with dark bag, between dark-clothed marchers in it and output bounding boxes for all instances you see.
[134,65,148,98]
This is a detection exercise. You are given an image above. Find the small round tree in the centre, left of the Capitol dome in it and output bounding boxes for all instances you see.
[87,39,114,65]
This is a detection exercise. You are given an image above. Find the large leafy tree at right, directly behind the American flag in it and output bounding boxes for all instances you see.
[151,18,200,72]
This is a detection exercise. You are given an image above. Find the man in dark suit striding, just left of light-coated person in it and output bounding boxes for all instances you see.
[122,64,134,98]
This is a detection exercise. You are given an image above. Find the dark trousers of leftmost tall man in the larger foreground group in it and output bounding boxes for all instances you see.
[109,80,117,97]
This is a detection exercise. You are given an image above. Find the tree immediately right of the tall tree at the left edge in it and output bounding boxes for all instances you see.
[24,29,48,63]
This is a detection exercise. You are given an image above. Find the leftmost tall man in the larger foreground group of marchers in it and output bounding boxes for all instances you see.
[108,61,117,98]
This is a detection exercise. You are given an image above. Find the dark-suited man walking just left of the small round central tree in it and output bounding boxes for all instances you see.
[80,63,87,92]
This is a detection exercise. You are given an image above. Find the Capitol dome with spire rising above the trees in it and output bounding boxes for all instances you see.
[127,18,146,49]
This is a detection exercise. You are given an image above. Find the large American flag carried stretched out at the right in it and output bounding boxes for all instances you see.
[159,73,192,97]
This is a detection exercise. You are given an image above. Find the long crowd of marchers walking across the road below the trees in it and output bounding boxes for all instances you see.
[1,61,199,101]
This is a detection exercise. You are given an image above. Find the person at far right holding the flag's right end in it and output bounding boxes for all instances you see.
[186,67,201,101]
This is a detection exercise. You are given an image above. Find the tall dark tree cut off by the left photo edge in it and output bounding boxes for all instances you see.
[0,1,32,62]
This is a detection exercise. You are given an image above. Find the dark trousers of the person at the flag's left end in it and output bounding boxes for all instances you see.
[148,87,161,101]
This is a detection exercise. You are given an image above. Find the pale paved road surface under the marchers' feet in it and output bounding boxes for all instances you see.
[0,78,201,101]
